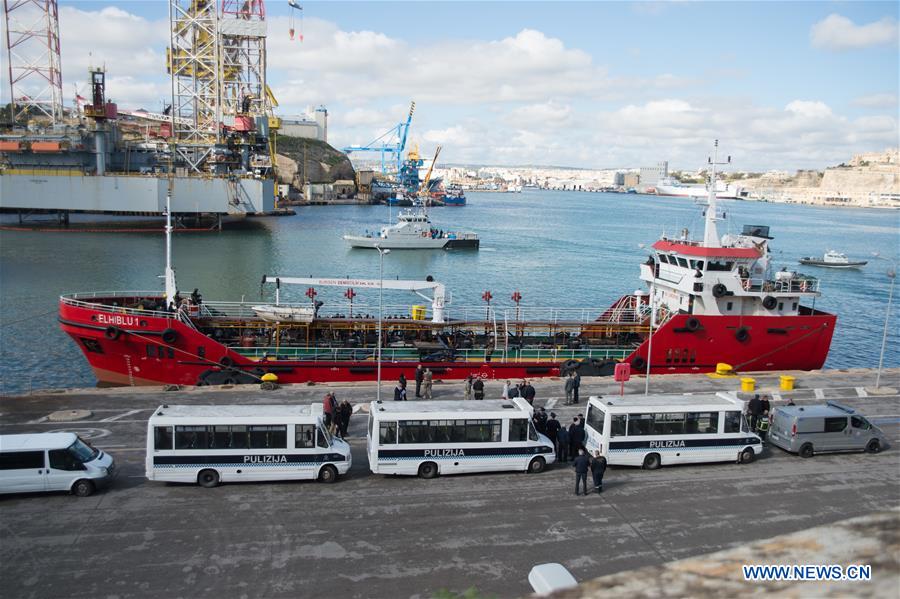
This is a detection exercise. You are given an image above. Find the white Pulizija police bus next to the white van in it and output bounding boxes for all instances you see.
[146,404,351,487]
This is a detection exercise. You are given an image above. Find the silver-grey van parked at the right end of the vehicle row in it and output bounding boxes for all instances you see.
[768,401,888,458]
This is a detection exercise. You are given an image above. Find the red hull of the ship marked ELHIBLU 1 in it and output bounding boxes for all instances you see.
[59,298,836,386]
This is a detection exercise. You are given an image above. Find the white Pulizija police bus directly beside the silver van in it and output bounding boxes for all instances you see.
[585,393,762,470]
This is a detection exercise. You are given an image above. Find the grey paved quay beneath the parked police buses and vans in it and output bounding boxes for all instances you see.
[0,369,900,599]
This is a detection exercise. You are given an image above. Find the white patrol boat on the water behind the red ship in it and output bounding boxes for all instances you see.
[344,204,480,250]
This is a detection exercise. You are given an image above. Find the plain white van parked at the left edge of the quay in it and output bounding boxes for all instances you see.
[0,433,115,497]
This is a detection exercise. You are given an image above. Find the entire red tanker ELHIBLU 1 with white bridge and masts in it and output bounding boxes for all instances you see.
[59,143,836,385]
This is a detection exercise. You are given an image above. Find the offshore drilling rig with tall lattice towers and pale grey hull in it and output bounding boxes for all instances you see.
[0,0,279,226]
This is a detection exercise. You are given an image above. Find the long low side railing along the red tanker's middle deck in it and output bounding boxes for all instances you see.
[231,346,632,364]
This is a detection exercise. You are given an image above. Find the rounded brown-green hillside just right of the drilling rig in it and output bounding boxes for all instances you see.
[276,135,356,188]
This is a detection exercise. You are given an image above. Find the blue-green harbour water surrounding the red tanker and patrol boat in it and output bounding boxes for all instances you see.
[0,190,900,393]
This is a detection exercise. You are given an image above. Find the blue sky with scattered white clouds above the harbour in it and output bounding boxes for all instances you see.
[8,0,900,169]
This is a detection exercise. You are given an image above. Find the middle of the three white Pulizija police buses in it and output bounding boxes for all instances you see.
[367,398,556,478]
